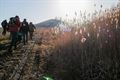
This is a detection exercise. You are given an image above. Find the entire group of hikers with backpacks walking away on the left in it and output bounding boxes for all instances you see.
[1,16,36,52]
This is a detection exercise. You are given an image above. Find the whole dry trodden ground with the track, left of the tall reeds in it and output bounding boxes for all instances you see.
[0,31,54,80]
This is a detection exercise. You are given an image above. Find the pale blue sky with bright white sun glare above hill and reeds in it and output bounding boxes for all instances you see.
[0,0,119,23]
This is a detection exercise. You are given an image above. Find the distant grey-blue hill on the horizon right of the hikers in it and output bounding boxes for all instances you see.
[35,19,63,28]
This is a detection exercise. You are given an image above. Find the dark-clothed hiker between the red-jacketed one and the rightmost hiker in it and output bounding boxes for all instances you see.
[20,19,29,45]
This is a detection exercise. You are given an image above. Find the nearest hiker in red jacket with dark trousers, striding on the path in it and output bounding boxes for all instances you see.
[8,17,20,52]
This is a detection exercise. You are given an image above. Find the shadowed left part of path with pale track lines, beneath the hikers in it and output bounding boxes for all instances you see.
[0,41,34,80]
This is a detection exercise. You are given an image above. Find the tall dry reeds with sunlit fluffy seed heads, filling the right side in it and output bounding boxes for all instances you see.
[35,4,120,80]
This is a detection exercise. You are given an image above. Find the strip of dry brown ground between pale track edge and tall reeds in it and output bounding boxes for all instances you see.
[20,35,44,80]
